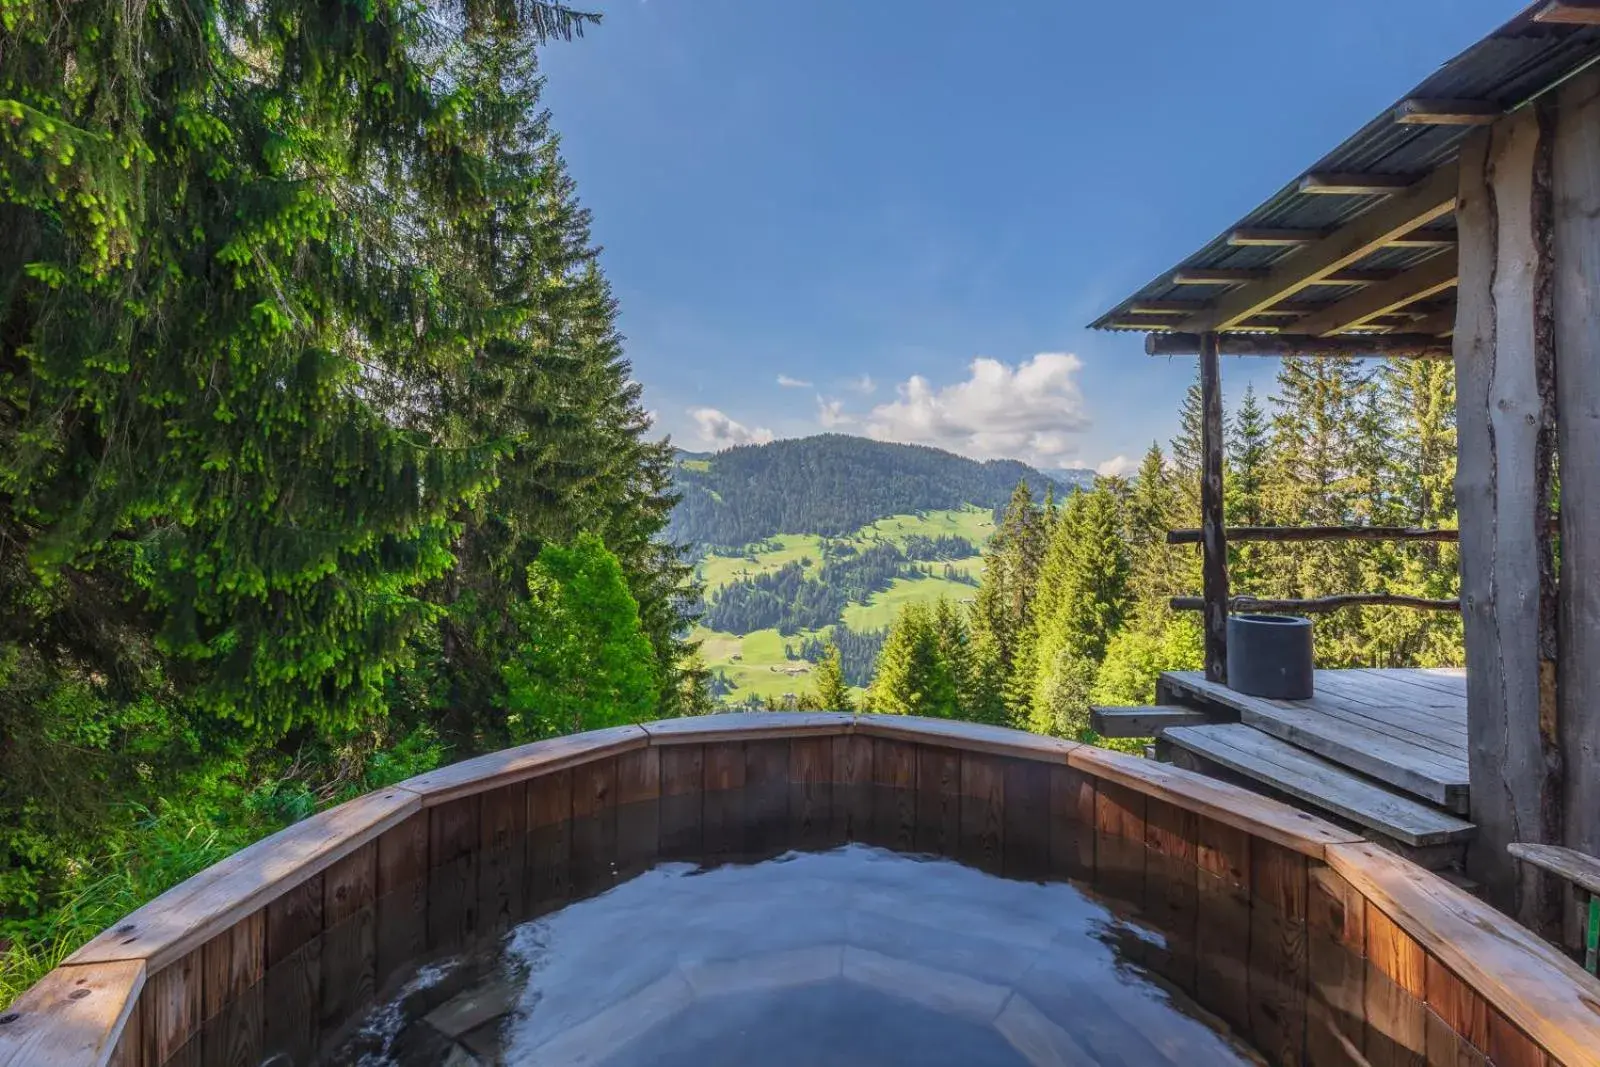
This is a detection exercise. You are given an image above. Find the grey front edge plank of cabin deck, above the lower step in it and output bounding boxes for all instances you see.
[1162,670,1467,813]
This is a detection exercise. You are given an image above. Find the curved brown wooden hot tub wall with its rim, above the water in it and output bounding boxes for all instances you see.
[0,713,1600,1067]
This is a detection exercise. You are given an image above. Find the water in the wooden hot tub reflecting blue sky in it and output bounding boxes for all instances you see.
[323,845,1259,1067]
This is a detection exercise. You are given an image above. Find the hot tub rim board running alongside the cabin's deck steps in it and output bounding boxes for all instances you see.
[1072,745,1362,859]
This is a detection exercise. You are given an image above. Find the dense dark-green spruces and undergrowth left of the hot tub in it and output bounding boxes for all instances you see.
[0,0,706,1003]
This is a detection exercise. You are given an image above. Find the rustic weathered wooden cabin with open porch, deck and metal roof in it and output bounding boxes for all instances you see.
[1094,0,1600,937]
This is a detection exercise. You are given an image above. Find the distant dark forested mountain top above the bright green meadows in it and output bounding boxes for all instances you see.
[667,434,1094,545]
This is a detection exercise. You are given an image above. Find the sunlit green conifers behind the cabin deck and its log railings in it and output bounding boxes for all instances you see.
[774,358,1464,737]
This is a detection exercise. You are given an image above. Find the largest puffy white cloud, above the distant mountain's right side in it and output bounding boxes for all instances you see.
[867,352,1090,467]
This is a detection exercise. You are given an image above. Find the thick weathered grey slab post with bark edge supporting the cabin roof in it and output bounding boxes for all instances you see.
[1454,107,1562,931]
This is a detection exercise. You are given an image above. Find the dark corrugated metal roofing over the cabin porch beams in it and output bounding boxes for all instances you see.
[1093,0,1600,333]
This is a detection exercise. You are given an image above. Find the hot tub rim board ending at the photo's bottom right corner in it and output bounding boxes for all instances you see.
[1328,845,1600,1067]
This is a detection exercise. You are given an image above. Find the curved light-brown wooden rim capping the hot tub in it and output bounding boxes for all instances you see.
[0,712,1600,1067]
